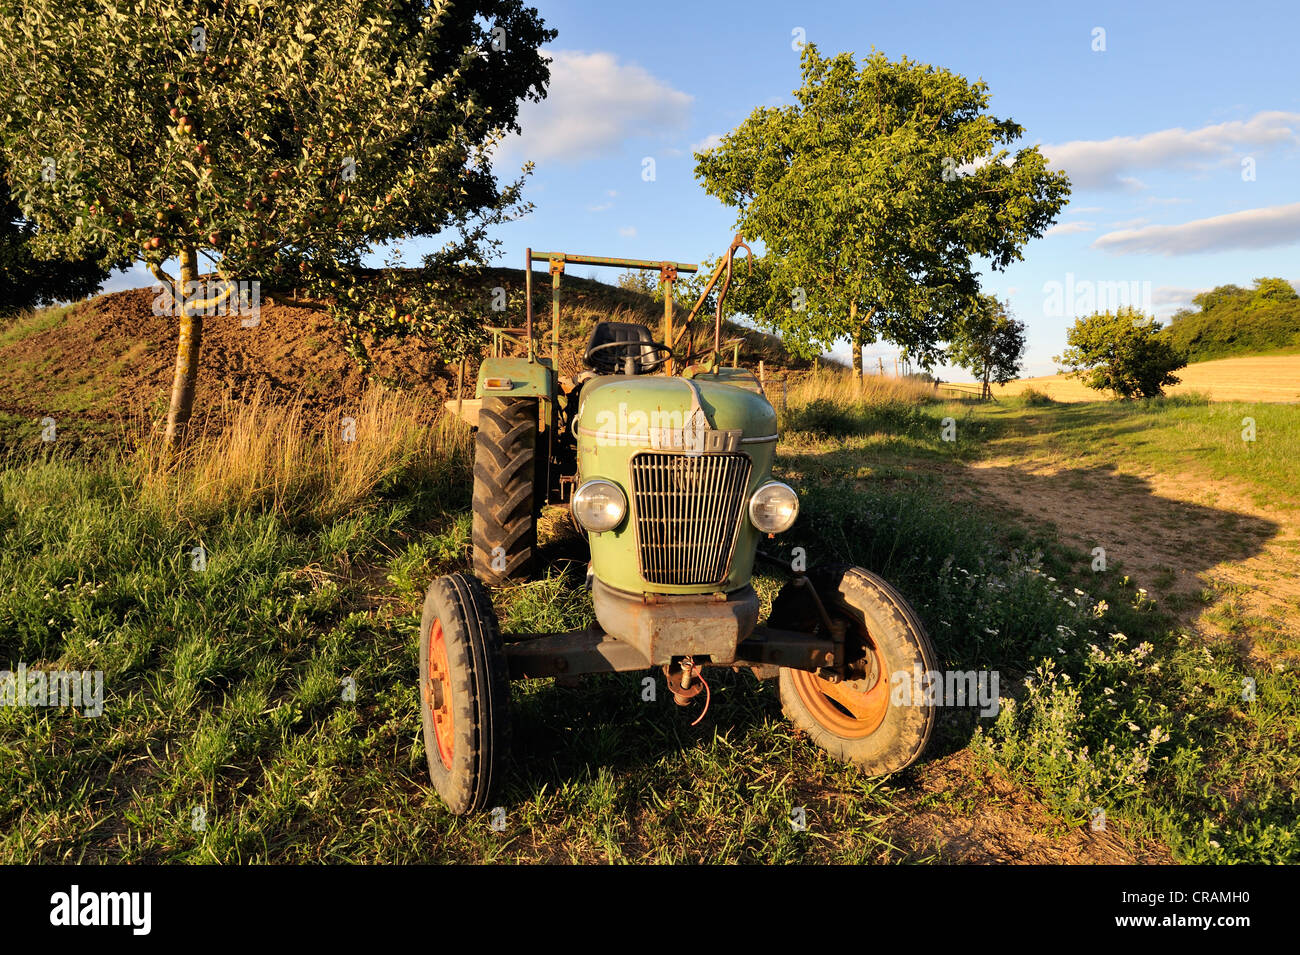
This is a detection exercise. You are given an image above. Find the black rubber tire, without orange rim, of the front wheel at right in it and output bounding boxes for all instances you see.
[770,567,936,776]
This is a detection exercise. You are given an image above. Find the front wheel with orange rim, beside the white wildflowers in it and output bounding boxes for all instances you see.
[771,567,936,776]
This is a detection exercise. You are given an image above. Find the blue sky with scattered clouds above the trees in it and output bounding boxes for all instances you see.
[104,0,1300,377]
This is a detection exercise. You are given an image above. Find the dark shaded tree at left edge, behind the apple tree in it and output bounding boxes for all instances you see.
[0,161,130,314]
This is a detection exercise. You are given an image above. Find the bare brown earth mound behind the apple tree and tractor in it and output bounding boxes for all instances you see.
[0,269,807,444]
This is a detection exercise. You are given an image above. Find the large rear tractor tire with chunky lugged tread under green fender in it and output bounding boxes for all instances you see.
[472,398,545,583]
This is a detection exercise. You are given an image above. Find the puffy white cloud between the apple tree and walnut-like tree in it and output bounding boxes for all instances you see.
[499,49,694,162]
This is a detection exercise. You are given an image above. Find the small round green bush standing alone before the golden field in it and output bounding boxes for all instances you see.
[1053,308,1187,398]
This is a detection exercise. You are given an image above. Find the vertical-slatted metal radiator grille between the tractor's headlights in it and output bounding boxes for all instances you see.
[631,452,750,585]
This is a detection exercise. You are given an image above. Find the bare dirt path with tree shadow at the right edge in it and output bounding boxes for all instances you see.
[950,457,1300,661]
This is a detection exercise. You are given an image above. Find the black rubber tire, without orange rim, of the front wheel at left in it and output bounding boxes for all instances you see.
[420,573,510,816]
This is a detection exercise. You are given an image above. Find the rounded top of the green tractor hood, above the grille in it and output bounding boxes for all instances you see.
[577,374,776,451]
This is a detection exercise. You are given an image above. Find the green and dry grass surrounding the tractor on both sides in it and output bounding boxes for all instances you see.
[0,376,1300,863]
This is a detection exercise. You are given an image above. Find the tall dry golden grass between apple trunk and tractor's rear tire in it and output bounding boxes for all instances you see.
[135,387,469,520]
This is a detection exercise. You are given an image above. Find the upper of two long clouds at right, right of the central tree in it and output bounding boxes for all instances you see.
[1043,110,1300,190]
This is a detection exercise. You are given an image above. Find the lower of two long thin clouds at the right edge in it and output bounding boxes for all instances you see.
[1092,203,1300,256]
